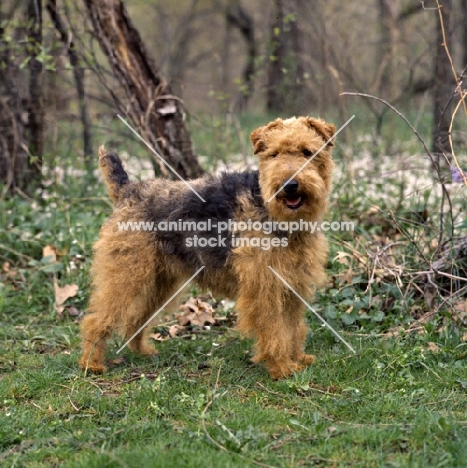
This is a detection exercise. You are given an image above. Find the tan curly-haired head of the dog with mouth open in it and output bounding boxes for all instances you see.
[251,117,336,221]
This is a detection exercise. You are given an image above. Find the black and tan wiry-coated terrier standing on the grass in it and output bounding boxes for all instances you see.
[80,117,335,379]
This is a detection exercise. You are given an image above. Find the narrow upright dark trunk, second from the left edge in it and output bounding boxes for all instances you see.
[27,0,44,183]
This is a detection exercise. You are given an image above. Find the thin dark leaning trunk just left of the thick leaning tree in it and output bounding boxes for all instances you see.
[47,0,94,163]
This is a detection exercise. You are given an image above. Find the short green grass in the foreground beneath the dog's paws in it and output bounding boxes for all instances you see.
[0,323,467,467]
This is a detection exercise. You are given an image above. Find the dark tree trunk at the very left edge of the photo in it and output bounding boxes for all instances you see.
[0,5,29,192]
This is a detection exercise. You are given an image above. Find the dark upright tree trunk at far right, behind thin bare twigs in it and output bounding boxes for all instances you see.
[432,0,456,168]
